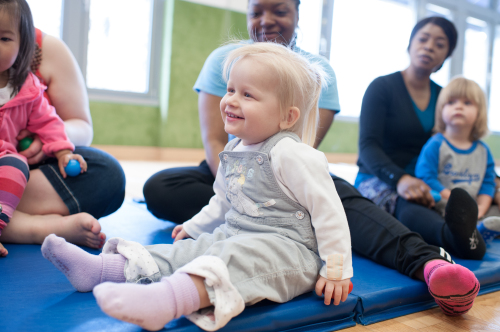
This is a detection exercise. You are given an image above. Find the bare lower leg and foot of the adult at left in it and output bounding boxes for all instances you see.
[2,211,106,249]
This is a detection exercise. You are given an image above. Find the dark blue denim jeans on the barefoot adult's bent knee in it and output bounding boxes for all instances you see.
[34,147,125,219]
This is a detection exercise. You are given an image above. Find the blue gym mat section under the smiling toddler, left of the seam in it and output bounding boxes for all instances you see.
[0,200,358,332]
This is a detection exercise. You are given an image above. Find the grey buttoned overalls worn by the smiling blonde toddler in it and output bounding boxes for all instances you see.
[102,132,323,326]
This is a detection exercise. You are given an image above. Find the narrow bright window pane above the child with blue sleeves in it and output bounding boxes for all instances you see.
[463,17,489,91]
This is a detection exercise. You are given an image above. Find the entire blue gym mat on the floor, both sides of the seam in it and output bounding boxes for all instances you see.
[0,200,500,332]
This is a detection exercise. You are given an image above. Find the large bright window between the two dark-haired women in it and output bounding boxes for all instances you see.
[330,0,415,117]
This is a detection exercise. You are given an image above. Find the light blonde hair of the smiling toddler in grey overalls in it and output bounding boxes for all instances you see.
[223,43,326,146]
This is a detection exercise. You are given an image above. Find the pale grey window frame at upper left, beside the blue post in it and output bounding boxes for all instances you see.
[61,0,165,106]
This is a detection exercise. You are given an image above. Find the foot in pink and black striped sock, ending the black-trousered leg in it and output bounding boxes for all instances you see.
[424,260,479,316]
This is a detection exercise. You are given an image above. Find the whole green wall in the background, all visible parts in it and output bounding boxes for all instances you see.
[90,0,500,159]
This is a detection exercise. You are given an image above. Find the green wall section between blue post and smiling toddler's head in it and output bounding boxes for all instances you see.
[159,0,248,148]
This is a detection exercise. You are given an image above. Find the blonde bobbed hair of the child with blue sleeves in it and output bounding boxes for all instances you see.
[434,76,488,141]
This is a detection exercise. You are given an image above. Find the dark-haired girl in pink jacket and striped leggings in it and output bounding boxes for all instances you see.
[0,0,87,257]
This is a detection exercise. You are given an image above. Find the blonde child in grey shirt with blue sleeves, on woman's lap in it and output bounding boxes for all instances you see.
[415,77,500,242]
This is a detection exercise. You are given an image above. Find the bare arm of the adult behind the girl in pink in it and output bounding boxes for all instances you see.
[39,35,94,146]
